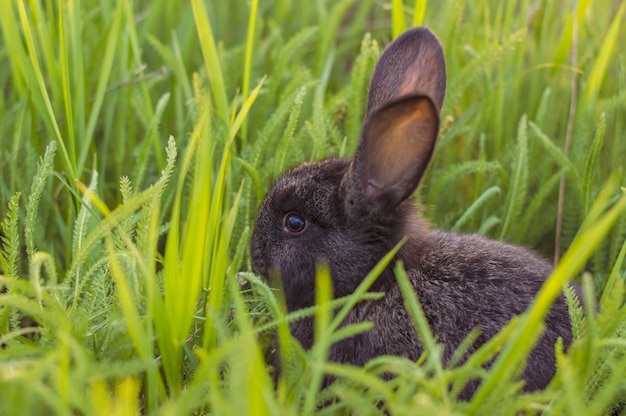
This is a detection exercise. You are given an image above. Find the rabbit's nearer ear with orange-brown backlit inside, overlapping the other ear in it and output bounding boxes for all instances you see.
[341,95,439,219]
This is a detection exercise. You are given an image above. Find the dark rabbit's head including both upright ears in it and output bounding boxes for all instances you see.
[252,27,446,310]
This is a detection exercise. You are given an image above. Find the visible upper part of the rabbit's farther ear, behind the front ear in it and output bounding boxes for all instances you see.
[367,26,446,117]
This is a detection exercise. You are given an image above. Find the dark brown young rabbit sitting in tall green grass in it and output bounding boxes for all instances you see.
[251,27,572,399]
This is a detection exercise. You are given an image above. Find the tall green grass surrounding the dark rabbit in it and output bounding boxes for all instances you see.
[0,0,626,415]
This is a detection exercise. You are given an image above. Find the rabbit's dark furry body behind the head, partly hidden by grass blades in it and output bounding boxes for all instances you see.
[329,231,572,390]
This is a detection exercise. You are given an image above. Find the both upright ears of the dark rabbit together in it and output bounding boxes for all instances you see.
[341,27,446,220]
